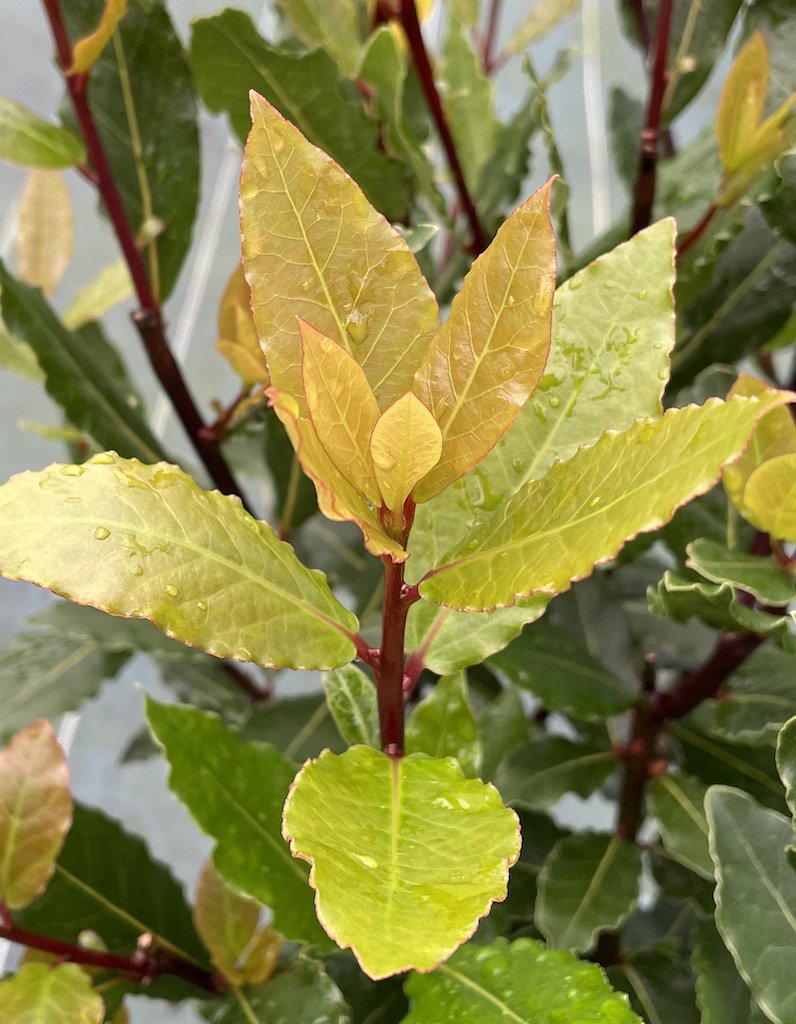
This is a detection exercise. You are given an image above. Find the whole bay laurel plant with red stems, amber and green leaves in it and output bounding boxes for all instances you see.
[0,0,796,1024]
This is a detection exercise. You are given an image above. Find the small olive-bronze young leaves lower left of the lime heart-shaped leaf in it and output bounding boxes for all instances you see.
[194,860,282,985]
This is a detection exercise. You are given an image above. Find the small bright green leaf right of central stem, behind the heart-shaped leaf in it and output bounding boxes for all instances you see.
[407,672,480,776]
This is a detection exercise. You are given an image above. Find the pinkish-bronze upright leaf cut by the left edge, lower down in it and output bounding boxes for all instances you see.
[0,719,72,910]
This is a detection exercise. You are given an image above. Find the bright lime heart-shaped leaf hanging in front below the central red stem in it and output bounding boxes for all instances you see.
[284,746,519,978]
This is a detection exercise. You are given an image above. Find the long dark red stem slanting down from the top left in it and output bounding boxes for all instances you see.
[42,0,252,512]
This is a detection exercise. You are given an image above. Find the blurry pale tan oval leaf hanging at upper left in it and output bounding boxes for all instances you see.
[16,170,75,295]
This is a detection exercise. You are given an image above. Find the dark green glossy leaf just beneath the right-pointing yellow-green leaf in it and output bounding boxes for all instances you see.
[490,621,634,721]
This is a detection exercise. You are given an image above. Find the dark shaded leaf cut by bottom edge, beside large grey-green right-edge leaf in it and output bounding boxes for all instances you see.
[693,921,754,1024]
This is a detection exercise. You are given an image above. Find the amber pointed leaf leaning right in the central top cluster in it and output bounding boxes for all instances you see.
[413,181,555,501]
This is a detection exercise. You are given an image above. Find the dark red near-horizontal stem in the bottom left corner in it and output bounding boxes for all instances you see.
[0,907,225,992]
